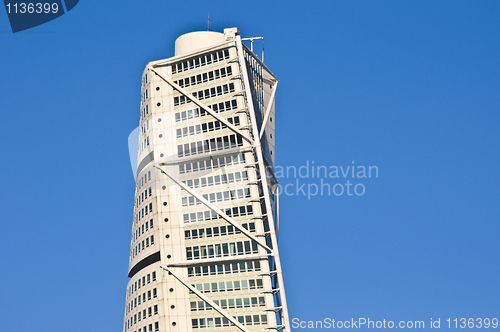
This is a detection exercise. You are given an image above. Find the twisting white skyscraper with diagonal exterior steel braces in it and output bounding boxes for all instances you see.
[124,28,289,332]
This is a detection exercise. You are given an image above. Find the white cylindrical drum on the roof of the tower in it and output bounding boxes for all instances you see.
[175,31,226,56]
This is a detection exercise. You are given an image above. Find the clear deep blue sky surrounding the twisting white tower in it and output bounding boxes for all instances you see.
[0,1,500,332]
